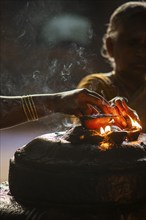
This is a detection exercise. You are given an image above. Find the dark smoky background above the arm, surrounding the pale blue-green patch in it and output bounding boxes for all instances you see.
[0,0,132,95]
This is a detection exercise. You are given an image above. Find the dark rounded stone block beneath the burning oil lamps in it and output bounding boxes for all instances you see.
[9,131,146,208]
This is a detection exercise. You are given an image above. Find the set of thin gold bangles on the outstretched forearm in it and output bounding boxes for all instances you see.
[21,95,38,121]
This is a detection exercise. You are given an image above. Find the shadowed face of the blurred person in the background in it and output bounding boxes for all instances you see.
[107,16,146,77]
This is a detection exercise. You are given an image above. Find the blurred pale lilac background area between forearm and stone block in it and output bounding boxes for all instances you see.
[0,123,48,183]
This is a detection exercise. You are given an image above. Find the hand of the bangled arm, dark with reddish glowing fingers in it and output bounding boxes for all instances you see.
[57,88,109,117]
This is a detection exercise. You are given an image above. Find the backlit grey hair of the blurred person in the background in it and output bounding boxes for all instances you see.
[101,1,146,67]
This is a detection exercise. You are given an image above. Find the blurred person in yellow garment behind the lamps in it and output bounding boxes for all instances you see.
[78,1,146,132]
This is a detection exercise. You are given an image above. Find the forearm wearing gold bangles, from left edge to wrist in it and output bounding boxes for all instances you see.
[0,94,58,129]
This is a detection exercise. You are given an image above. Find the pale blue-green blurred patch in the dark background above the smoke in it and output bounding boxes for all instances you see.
[42,13,91,45]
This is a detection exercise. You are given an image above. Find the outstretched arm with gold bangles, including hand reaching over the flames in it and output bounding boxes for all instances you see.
[0,89,107,129]
